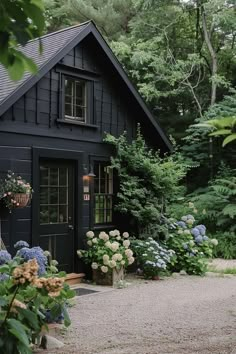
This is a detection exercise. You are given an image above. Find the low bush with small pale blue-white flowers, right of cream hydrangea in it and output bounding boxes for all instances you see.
[132,237,175,279]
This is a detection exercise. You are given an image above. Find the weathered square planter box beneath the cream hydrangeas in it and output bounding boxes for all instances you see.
[93,267,124,286]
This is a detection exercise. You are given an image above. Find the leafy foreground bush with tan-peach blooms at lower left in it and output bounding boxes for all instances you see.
[0,241,74,354]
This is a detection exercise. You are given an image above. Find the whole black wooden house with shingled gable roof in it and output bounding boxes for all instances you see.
[0,21,170,273]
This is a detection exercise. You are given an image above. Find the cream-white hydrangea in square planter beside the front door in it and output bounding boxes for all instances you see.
[77,230,134,285]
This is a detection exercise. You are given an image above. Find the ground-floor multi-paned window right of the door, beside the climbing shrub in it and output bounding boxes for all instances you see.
[94,163,113,224]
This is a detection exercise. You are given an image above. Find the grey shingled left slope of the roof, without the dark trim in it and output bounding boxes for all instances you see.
[0,22,89,105]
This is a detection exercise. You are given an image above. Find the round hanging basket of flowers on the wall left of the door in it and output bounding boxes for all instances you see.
[0,171,33,210]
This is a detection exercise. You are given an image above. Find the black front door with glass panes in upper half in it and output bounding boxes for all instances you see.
[39,160,75,273]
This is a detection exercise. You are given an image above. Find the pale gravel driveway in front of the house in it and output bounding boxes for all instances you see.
[50,276,236,354]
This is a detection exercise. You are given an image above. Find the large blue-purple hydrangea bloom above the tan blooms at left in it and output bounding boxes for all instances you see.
[17,247,48,275]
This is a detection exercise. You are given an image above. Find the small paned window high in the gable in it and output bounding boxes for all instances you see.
[65,77,87,123]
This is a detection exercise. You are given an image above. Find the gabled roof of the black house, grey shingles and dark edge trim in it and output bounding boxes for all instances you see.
[0,21,172,150]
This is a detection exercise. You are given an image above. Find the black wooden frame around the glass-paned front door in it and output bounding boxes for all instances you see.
[31,147,84,271]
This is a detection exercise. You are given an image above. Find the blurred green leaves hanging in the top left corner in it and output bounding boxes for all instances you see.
[0,0,45,80]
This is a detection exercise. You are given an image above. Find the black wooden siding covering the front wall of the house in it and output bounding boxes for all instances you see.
[0,25,168,271]
